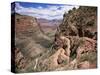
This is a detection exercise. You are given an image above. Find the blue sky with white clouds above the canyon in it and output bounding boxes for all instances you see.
[12,2,79,20]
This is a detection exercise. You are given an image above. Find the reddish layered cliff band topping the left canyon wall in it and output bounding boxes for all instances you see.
[15,14,42,36]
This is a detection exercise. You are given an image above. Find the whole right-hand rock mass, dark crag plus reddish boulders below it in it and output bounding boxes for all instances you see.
[54,6,97,70]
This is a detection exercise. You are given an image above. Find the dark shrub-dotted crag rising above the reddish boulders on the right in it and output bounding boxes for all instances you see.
[59,6,97,39]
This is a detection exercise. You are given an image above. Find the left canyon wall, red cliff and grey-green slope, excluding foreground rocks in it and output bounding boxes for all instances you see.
[15,14,50,57]
